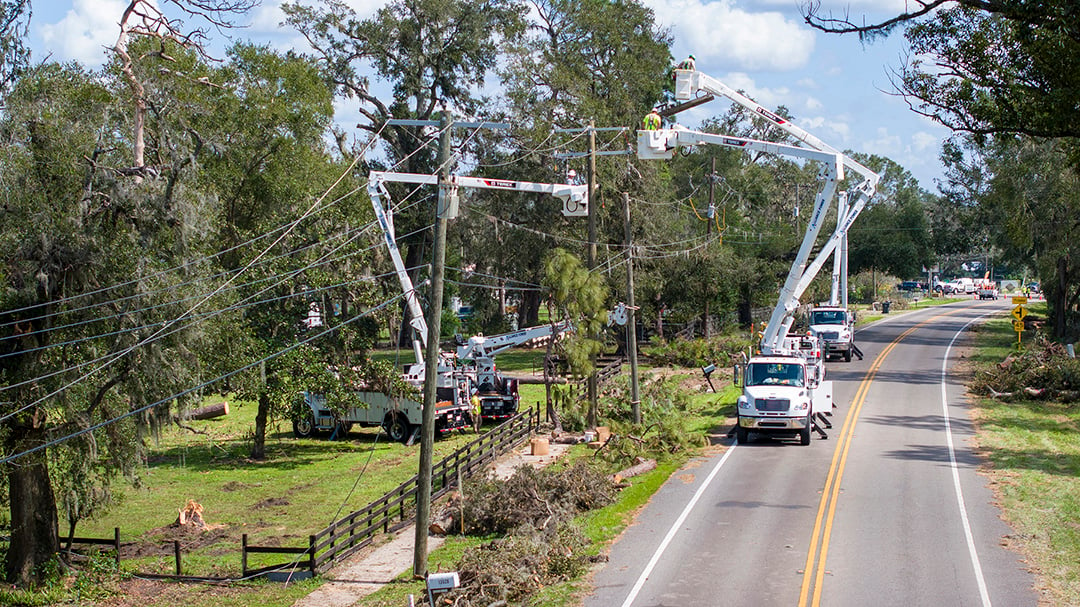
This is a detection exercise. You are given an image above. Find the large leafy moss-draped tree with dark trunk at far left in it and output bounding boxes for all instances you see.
[0,64,217,583]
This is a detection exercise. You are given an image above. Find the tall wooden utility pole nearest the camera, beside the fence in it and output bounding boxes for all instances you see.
[413,110,454,577]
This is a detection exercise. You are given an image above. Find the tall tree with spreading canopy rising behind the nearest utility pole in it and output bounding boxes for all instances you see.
[283,0,523,343]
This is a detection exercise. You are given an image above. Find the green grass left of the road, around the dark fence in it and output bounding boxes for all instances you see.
[50,350,737,607]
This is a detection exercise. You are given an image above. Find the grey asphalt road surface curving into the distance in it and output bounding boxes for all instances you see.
[584,300,1038,607]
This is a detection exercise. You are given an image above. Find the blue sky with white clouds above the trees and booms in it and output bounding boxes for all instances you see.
[30,0,949,191]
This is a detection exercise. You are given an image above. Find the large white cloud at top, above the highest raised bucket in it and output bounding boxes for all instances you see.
[645,0,814,71]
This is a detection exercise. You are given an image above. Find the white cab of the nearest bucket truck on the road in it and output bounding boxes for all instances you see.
[735,345,833,445]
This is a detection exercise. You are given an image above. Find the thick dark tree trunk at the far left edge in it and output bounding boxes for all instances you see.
[4,421,60,586]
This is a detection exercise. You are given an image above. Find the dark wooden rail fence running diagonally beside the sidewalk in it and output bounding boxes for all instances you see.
[241,407,540,578]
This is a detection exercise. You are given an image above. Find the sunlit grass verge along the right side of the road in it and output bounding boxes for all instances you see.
[972,304,1080,605]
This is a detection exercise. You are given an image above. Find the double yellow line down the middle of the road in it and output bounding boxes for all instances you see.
[799,310,959,607]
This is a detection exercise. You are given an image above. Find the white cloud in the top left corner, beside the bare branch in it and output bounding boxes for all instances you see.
[39,0,127,66]
